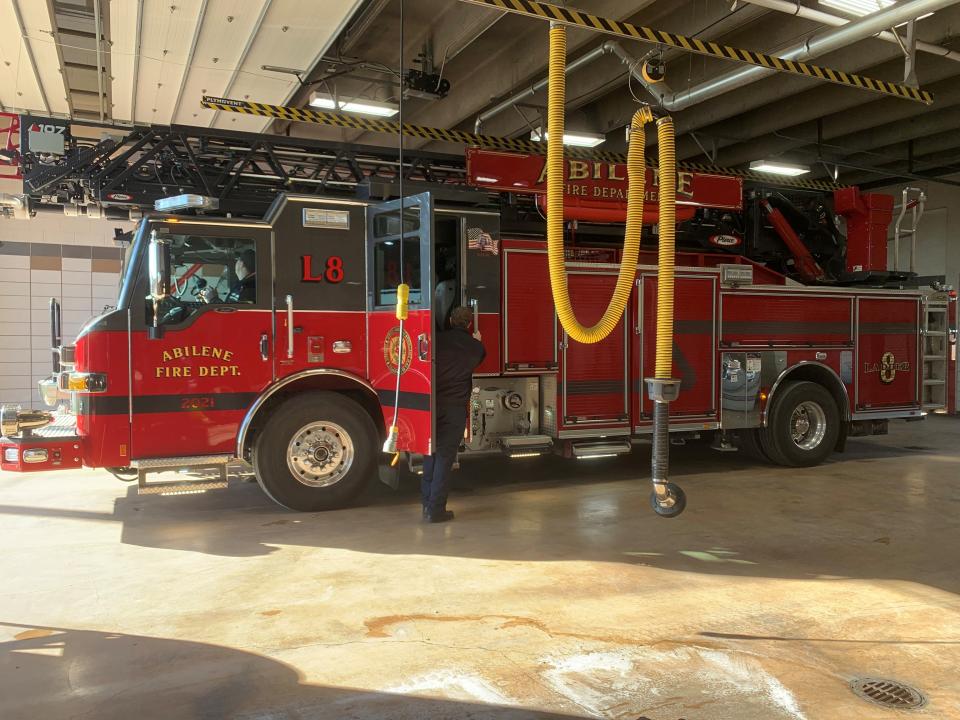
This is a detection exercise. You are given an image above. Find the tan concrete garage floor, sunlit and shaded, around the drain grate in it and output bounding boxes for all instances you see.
[0,417,960,720]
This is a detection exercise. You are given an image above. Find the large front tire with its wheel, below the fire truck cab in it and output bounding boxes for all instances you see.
[252,392,379,512]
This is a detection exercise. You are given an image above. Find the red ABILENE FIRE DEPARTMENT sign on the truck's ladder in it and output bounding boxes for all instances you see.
[467,148,743,219]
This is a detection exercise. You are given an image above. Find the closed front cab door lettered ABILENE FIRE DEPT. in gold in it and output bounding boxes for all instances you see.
[129,220,273,459]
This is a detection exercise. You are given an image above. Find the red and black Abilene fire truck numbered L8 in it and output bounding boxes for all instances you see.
[2,154,956,511]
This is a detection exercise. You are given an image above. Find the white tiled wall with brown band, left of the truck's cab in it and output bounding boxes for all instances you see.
[0,213,132,409]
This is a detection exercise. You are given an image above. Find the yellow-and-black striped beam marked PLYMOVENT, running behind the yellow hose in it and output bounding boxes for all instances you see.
[200,95,841,191]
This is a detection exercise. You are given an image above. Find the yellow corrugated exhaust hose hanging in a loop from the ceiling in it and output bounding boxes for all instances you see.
[547,25,676,358]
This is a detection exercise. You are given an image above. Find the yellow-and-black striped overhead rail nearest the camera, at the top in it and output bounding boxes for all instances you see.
[460,0,933,105]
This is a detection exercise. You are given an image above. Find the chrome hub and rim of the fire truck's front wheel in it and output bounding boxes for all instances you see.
[287,420,354,487]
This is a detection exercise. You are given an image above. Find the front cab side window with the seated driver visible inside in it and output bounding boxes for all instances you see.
[147,235,258,325]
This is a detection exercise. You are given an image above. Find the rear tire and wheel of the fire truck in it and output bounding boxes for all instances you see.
[759,381,840,467]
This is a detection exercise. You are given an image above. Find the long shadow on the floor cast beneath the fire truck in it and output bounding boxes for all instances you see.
[0,418,960,593]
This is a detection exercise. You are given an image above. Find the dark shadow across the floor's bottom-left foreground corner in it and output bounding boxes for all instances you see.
[0,623,573,720]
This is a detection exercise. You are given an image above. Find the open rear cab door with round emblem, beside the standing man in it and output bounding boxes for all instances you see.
[367,193,436,455]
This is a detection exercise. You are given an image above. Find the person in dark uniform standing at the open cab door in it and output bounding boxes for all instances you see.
[420,307,487,523]
